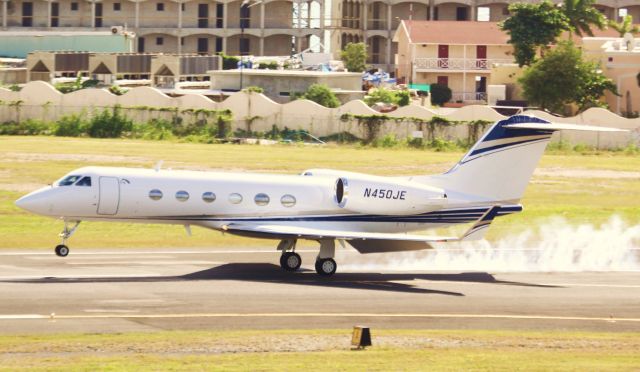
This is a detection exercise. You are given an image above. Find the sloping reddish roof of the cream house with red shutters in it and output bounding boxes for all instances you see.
[402,21,509,45]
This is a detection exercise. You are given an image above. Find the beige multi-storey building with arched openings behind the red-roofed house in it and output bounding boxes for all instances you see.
[331,0,640,71]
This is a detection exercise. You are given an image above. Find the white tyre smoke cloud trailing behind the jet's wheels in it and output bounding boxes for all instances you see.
[341,216,640,272]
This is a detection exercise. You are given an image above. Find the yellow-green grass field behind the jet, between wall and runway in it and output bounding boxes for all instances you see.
[0,137,640,249]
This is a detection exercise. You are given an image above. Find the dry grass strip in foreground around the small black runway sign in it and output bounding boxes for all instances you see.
[0,330,640,371]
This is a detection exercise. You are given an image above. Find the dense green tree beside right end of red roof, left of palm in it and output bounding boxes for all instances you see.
[500,0,570,67]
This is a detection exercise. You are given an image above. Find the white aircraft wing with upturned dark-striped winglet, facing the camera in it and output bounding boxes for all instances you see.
[223,206,500,253]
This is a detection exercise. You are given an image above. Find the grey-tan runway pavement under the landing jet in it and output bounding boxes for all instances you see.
[0,248,640,334]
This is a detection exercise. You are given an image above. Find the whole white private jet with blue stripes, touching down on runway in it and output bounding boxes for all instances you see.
[16,115,616,275]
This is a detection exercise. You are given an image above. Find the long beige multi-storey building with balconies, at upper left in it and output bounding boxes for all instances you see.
[0,0,326,56]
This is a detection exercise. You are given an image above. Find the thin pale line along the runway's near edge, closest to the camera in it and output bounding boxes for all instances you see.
[0,313,640,323]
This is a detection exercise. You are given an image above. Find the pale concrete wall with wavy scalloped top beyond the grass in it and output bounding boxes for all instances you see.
[0,81,640,148]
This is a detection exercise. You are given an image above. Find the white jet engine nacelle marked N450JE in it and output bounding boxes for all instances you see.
[335,176,447,215]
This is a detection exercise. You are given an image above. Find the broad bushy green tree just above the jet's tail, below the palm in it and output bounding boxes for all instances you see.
[518,42,617,113]
